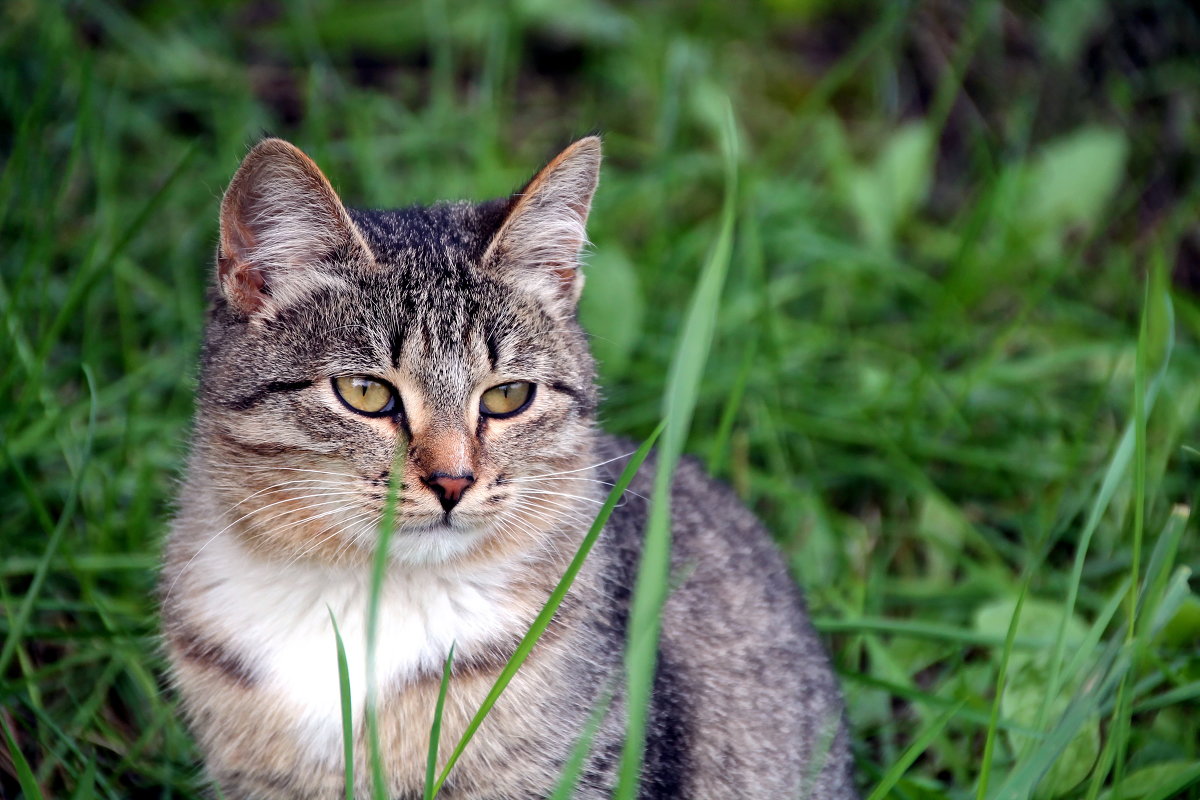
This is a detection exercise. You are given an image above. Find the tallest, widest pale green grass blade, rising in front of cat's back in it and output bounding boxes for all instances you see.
[613,98,737,800]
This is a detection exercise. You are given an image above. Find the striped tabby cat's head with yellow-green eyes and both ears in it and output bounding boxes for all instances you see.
[191,137,600,564]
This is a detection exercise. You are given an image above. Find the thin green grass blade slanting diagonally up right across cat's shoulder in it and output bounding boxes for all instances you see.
[433,422,666,795]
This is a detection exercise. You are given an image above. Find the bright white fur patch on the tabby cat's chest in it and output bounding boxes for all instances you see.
[192,537,521,753]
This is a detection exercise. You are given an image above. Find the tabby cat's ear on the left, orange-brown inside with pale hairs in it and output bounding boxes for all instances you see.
[217,139,370,317]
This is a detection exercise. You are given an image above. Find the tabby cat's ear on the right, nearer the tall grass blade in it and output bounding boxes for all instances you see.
[482,136,600,313]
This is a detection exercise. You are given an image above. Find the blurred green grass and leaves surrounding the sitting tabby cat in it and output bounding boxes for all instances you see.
[0,0,1200,800]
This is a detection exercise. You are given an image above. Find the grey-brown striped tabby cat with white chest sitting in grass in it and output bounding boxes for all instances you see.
[160,137,856,800]
